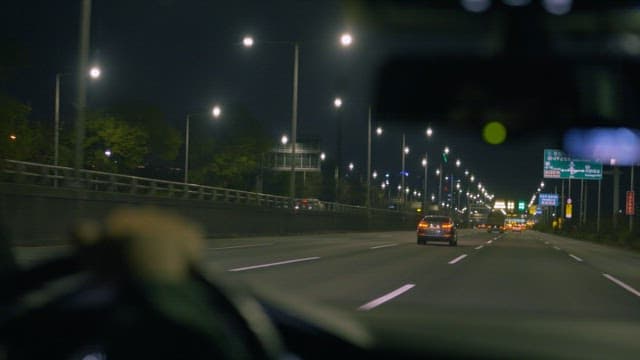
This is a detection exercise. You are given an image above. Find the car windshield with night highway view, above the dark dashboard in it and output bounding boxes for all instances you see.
[0,0,640,358]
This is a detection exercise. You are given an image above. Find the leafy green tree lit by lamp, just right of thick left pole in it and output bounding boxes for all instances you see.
[85,112,149,172]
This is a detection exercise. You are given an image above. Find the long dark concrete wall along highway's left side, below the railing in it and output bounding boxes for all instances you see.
[0,183,418,245]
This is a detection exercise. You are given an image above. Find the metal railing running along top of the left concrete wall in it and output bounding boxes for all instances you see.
[0,159,398,214]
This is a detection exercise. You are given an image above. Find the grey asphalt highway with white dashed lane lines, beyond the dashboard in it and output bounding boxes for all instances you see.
[201,230,640,319]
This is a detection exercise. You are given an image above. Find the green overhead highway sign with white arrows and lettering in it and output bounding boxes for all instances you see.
[544,149,602,180]
